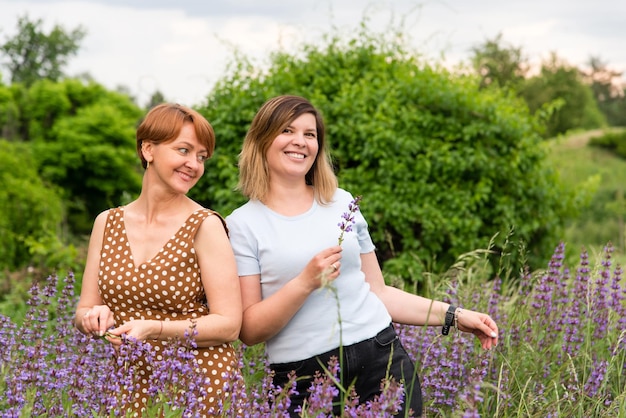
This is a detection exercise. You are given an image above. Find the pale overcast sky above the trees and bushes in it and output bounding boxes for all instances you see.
[0,0,626,106]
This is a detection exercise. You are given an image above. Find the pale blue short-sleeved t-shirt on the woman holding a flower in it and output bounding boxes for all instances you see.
[226,189,391,363]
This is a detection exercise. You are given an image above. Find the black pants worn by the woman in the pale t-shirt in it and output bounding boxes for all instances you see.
[270,325,422,417]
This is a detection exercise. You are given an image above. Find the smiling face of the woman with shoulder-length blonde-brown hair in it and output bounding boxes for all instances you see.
[266,113,319,181]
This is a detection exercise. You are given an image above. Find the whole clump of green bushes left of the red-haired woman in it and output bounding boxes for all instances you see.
[0,79,143,271]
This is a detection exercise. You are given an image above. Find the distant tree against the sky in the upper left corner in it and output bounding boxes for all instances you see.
[0,15,86,86]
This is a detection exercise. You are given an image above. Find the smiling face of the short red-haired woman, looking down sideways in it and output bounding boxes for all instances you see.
[144,123,209,194]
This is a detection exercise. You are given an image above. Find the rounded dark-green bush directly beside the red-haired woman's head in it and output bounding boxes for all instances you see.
[36,99,141,233]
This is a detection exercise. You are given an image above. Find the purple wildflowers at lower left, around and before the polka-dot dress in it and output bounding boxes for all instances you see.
[0,274,228,417]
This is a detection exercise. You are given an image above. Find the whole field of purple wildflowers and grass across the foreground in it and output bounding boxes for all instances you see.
[0,240,626,418]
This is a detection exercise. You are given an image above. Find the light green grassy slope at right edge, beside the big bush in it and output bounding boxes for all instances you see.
[549,126,626,265]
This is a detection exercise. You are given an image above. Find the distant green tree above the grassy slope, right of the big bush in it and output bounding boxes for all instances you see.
[520,53,606,137]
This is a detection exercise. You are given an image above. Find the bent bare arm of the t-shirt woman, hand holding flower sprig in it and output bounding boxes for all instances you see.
[239,246,341,345]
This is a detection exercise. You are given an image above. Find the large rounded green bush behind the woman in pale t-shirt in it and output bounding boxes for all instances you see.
[193,29,572,284]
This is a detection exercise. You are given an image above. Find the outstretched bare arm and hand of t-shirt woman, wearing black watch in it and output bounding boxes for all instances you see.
[361,252,498,349]
